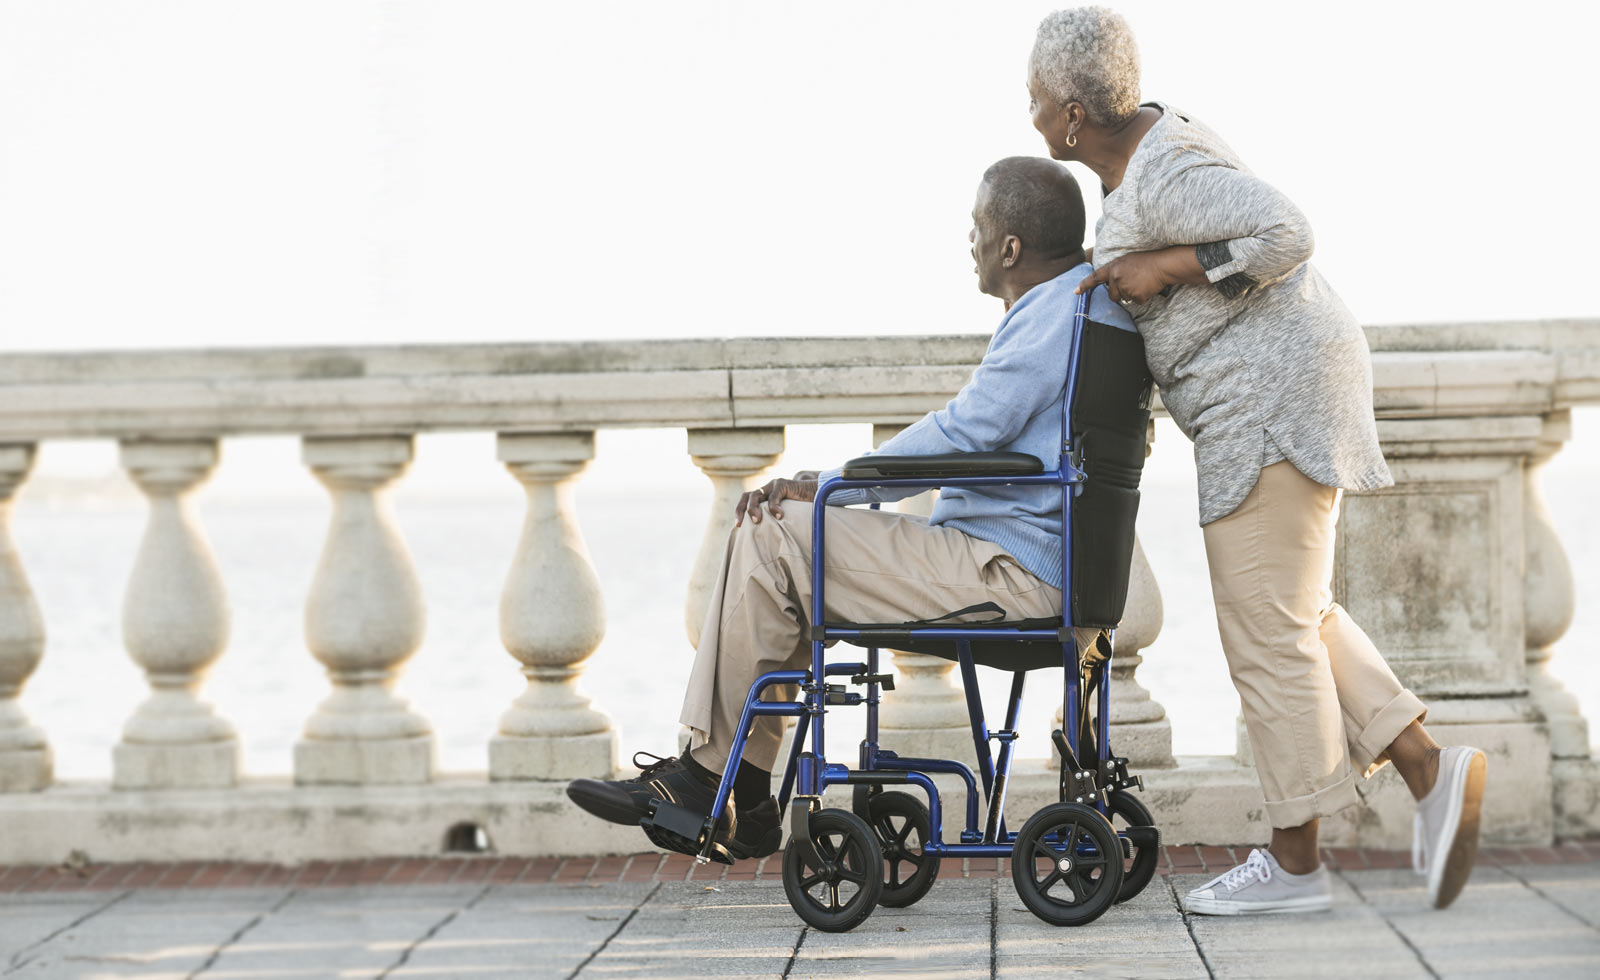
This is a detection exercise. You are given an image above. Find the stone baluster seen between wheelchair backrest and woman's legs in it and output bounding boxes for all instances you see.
[1050,423,1178,770]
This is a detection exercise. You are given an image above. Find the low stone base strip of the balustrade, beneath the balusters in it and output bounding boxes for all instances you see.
[0,756,1561,863]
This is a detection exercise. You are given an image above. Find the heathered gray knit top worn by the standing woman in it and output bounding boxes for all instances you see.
[1094,102,1394,524]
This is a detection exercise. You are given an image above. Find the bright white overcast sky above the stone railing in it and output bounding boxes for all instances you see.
[0,0,1600,349]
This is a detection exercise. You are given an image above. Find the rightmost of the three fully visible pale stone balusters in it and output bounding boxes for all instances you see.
[490,432,616,780]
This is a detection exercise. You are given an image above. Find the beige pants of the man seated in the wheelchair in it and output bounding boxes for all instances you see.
[678,500,1093,772]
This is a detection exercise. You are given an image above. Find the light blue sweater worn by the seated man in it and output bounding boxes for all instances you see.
[819,263,1134,589]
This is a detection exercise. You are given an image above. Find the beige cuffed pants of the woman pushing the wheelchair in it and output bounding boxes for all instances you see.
[1203,463,1427,828]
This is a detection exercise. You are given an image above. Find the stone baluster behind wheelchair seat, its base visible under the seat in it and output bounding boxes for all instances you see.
[872,424,973,759]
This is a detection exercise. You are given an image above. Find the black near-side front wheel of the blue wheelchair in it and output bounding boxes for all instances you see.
[784,809,883,932]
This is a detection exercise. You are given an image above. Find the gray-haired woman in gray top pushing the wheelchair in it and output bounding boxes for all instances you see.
[1027,6,1485,914]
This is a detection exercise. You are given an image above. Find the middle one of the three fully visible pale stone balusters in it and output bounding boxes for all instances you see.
[294,436,435,785]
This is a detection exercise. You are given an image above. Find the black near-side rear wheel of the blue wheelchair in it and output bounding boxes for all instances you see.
[1011,802,1122,926]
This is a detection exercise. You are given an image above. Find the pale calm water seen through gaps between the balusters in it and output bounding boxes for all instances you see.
[13,429,1600,778]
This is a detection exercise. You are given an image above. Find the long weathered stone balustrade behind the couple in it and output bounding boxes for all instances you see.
[0,320,1600,862]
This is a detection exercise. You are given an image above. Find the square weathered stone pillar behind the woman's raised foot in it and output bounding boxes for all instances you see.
[1333,416,1552,842]
